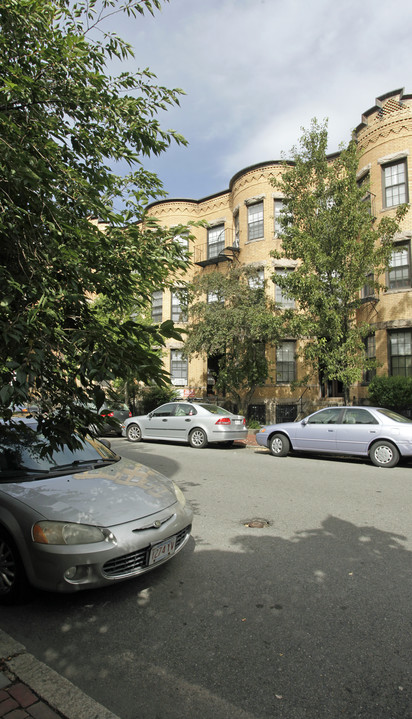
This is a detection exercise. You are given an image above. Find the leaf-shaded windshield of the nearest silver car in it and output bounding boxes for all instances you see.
[0,428,119,482]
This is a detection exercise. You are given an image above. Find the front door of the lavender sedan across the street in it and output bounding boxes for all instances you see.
[293,407,342,452]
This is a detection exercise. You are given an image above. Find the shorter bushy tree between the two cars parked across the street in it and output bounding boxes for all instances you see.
[184,266,281,415]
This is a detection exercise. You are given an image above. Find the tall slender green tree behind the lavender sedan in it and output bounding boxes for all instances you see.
[273,120,406,402]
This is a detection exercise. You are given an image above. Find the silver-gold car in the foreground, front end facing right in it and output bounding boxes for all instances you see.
[0,421,193,604]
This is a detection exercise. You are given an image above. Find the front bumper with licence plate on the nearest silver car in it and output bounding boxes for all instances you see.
[28,504,193,593]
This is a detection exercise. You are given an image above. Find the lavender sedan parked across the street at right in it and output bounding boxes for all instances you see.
[256,407,412,467]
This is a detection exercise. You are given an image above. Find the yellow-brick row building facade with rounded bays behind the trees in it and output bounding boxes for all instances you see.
[148,90,412,422]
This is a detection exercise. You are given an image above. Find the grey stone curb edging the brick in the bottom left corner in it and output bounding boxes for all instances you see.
[0,629,119,719]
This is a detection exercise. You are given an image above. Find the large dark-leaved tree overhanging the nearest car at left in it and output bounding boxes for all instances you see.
[0,0,188,444]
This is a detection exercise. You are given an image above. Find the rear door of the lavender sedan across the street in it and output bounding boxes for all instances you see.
[336,407,380,454]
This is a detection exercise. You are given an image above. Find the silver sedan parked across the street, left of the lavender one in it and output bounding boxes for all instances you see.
[122,401,247,449]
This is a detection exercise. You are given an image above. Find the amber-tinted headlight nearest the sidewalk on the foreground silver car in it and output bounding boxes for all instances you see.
[32,521,114,544]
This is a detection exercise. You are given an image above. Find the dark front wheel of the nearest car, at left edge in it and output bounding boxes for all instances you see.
[0,529,29,604]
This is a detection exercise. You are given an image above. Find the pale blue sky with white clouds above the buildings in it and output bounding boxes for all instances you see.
[104,0,412,199]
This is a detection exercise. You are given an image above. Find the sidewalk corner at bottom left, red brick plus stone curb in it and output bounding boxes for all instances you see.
[0,630,119,719]
